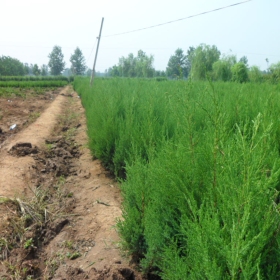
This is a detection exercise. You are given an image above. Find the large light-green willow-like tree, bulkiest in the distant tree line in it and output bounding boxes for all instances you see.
[191,44,221,80]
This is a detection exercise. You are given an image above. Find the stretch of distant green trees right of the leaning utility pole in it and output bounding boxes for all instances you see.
[108,44,280,83]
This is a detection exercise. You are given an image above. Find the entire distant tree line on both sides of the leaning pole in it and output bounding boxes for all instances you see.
[0,44,280,83]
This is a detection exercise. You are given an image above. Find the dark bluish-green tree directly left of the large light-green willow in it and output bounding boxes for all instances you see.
[166,48,188,78]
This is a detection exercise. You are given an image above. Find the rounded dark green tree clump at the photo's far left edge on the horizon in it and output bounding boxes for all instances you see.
[0,56,26,76]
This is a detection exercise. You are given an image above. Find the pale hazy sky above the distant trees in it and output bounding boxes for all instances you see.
[0,0,280,72]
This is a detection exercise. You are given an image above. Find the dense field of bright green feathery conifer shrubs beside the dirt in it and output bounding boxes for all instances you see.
[74,78,280,280]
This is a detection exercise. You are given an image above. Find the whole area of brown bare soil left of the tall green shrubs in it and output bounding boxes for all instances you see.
[0,87,144,280]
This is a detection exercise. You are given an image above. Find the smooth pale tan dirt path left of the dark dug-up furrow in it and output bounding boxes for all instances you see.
[0,88,67,197]
